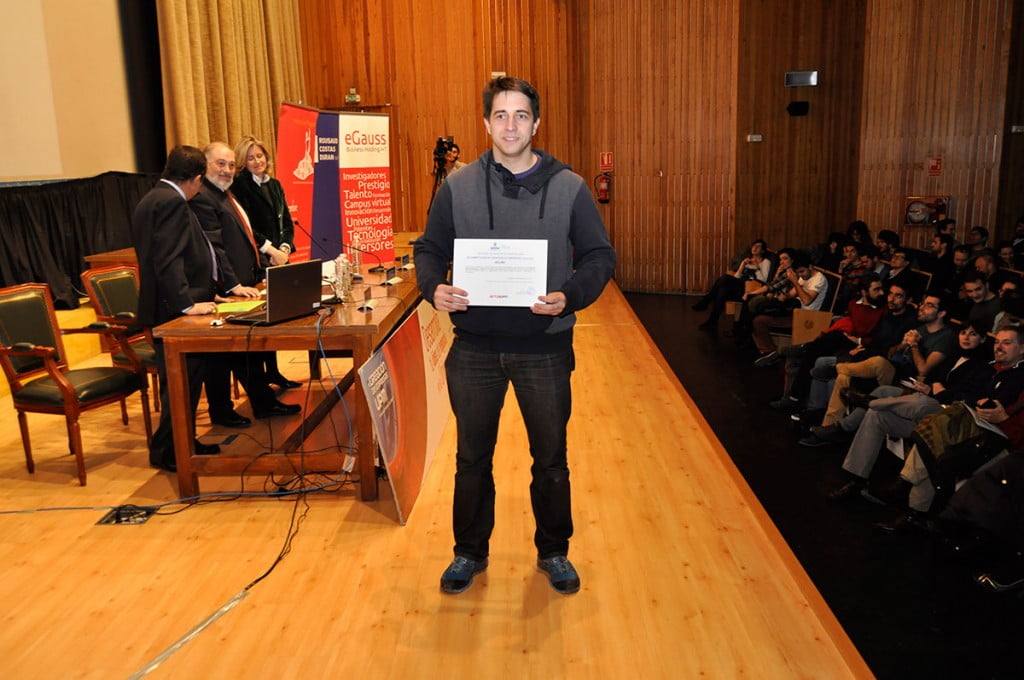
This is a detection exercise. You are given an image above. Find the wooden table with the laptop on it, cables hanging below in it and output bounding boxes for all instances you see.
[154,270,419,501]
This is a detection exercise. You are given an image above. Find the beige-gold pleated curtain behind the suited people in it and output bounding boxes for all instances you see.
[151,0,305,155]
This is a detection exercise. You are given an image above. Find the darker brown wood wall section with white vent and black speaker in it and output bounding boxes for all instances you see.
[735,0,864,264]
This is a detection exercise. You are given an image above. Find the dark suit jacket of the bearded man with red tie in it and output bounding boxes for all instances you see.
[191,177,265,292]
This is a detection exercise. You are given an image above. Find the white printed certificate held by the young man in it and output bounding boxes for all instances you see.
[452,239,548,307]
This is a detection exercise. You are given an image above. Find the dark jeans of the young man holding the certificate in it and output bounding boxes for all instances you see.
[444,338,573,560]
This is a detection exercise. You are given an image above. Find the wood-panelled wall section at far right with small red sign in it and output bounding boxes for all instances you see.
[858,0,1013,247]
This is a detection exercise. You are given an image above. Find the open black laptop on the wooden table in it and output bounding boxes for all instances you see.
[226,260,323,326]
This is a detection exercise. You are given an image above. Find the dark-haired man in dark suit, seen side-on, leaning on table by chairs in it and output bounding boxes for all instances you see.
[132,146,230,472]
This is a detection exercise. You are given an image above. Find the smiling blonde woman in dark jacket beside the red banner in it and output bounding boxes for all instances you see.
[231,136,295,264]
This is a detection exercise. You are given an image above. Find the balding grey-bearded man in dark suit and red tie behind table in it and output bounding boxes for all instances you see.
[191,141,301,427]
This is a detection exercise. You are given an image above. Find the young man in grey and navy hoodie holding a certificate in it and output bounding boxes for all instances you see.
[415,78,615,594]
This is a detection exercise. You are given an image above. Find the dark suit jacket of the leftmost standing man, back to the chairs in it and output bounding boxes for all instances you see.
[132,181,215,326]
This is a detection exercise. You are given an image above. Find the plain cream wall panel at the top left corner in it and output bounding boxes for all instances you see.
[0,0,136,181]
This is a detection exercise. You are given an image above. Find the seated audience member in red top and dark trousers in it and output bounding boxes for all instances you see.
[770,272,886,410]
